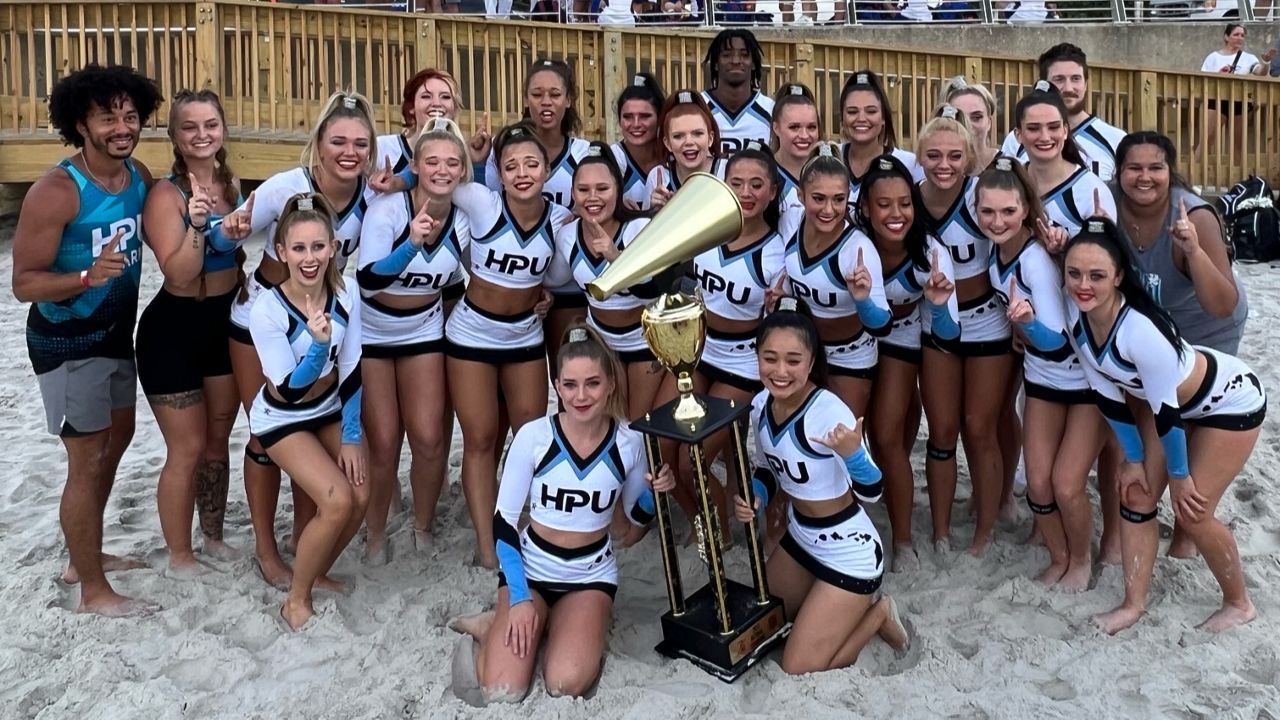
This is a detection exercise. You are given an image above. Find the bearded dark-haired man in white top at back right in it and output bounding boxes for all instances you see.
[1000,42,1125,182]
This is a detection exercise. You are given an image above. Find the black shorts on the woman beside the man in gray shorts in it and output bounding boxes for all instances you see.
[136,287,239,396]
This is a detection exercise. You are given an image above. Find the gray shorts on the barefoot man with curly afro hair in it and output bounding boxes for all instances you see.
[36,357,138,437]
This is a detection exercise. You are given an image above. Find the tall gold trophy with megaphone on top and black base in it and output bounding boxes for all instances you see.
[588,173,791,682]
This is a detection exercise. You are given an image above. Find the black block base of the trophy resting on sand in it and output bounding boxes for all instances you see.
[654,580,791,683]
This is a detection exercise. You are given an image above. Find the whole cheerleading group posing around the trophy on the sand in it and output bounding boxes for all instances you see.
[14,29,1266,701]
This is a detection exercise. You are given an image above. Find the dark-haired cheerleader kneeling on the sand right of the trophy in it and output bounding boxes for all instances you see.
[735,299,909,675]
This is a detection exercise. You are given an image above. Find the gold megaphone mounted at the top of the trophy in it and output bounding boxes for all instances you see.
[586,173,742,300]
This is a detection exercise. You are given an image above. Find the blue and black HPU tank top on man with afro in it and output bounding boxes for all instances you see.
[27,159,147,374]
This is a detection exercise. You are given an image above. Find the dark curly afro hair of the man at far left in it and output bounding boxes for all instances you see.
[49,64,164,147]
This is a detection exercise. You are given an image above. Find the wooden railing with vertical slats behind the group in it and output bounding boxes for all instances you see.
[0,0,1280,187]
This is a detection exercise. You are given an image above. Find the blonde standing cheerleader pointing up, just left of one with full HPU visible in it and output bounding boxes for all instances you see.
[356,118,472,565]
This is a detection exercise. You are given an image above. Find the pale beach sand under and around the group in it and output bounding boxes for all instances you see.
[0,220,1280,720]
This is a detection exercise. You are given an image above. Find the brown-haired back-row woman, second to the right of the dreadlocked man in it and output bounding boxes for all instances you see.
[840,70,922,202]
